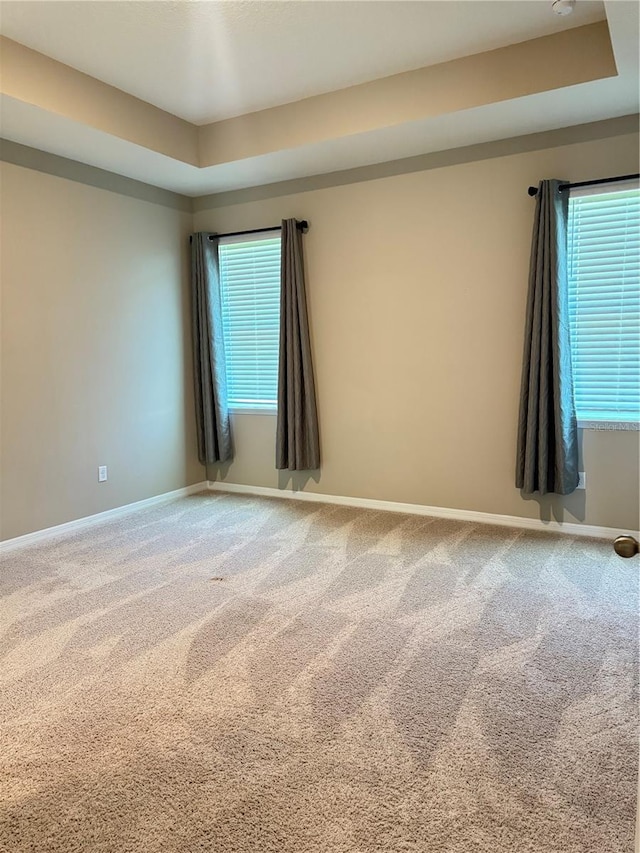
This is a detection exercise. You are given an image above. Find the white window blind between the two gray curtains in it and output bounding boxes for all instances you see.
[218,235,280,411]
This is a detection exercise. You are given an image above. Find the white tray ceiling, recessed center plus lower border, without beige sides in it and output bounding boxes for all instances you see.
[0,0,640,196]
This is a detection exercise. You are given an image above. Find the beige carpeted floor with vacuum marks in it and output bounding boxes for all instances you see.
[0,494,638,853]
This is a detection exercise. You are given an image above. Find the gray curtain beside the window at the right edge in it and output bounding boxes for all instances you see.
[516,180,578,495]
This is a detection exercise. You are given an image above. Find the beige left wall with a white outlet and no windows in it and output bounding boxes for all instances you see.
[0,164,204,539]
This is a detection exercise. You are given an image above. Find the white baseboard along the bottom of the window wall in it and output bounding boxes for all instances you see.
[209,480,640,539]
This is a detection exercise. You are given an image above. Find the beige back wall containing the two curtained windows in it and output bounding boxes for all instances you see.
[195,134,640,529]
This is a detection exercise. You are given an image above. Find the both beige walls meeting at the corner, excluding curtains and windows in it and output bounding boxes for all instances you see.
[0,126,640,539]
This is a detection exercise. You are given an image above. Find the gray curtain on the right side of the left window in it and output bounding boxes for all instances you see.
[276,219,320,471]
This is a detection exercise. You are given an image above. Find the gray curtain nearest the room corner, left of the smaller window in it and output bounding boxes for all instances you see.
[191,232,232,465]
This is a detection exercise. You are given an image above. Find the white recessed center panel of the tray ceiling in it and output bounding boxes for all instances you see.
[0,0,605,124]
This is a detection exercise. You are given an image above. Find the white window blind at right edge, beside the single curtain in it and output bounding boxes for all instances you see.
[568,185,640,424]
